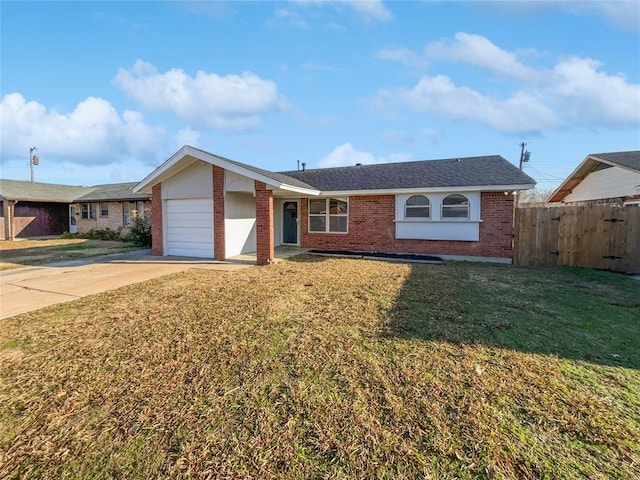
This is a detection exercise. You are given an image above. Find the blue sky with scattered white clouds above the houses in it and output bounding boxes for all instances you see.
[0,0,640,189]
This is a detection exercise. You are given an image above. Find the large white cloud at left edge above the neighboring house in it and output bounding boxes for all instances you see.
[0,93,163,165]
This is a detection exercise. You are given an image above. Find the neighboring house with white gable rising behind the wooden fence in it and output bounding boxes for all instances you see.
[548,150,640,205]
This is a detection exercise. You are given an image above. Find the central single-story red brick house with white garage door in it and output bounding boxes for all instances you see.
[133,146,535,264]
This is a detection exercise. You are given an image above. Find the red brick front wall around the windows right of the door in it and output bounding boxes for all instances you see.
[300,192,513,258]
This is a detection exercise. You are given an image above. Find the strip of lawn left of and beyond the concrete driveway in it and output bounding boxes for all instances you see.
[0,238,139,270]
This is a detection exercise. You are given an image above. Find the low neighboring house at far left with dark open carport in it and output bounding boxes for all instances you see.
[0,180,151,240]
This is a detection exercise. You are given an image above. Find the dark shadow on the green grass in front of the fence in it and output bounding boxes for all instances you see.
[380,262,640,369]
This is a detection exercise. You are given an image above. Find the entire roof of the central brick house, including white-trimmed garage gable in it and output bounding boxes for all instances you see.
[134,145,536,195]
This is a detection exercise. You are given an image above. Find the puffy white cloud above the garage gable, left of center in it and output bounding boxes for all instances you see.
[114,60,288,130]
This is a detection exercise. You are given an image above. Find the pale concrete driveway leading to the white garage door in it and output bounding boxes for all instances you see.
[0,250,252,319]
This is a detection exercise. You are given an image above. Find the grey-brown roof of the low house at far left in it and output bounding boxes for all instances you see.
[0,179,149,203]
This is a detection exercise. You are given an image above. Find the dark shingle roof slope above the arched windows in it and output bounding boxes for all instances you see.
[282,155,536,191]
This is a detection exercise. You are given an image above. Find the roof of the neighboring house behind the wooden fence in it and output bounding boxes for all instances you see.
[548,150,640,202]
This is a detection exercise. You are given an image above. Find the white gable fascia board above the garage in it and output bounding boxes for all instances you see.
[133,145,320,195]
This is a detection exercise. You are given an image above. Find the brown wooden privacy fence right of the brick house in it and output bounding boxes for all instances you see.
[513,205,640,273]
